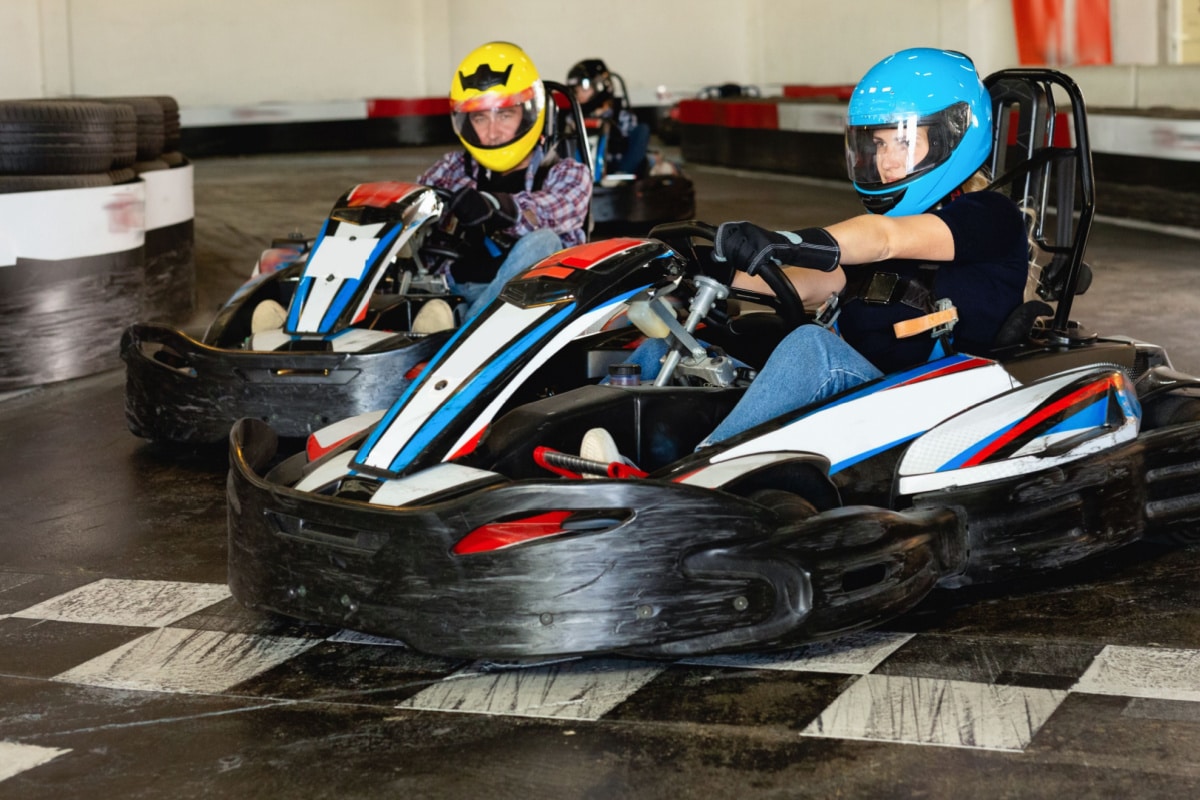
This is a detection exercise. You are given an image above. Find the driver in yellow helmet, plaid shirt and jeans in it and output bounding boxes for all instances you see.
[413,42,592,332]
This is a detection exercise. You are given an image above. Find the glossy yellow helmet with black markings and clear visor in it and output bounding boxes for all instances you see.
[450,42,546,173]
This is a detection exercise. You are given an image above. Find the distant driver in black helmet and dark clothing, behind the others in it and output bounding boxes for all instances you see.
[566,59,650,175]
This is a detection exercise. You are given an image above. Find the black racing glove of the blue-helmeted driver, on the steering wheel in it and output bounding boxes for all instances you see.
[713,222,841,275]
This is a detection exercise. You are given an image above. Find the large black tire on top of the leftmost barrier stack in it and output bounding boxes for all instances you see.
[0,100,115,175]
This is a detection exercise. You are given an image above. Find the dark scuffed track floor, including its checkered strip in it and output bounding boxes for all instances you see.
[0,149,1200,800]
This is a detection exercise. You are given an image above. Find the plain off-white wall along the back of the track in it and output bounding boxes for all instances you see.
[0,0,1195,109]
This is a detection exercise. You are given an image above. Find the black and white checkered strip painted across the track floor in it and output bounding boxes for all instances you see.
[0,575,1200,780]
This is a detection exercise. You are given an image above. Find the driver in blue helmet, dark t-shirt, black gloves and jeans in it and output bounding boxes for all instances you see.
[583,48,1030,462]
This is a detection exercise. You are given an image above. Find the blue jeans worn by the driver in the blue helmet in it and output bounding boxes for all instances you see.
[628,325,883,447]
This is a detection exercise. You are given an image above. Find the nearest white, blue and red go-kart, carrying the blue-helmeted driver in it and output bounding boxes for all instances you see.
[228,70,1200,658]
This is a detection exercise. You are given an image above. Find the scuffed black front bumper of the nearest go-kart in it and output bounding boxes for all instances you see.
[228,420,965,658]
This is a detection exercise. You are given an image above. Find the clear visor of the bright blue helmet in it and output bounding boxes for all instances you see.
[846,102,971,190]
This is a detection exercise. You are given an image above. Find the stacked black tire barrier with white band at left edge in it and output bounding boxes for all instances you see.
[0,96,196,391]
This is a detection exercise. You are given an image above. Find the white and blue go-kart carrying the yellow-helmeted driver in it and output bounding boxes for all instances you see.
[120,82,590,443]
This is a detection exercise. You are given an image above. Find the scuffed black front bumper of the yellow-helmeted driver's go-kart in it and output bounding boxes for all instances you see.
[121,324,445,443]
